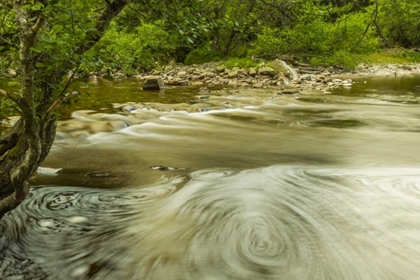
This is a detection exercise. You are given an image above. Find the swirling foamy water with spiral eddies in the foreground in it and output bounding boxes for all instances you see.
[0,166,420,280]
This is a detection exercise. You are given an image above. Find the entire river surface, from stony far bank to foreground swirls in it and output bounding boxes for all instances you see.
[0,77,420,280]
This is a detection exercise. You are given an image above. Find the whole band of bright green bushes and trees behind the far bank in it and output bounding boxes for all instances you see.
[71,0,420,69]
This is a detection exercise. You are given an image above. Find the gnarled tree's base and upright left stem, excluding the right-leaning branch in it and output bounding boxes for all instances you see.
[0,1,51,221]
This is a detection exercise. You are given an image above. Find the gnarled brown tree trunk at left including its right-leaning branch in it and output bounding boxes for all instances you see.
[0,0,130,219]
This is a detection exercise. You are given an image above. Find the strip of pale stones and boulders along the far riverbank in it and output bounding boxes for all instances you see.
[136,60,420,93]
